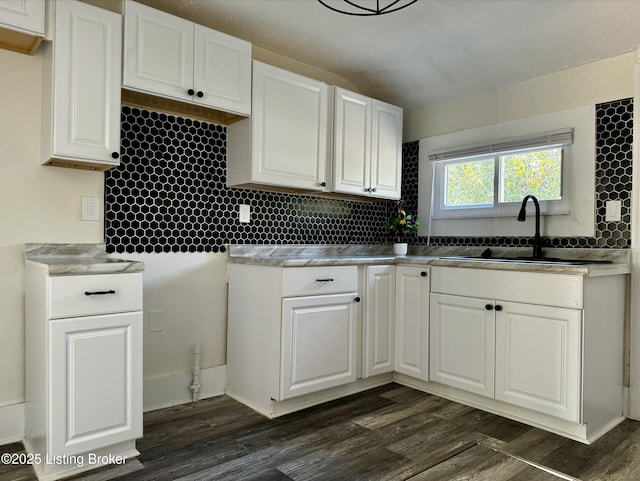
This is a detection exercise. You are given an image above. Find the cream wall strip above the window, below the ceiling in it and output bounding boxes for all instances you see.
[404,52,636,142]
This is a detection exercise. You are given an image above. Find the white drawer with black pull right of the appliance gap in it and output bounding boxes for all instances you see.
[282,266,358,297]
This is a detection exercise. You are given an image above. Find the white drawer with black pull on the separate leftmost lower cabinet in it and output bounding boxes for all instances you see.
[48,273,142,319]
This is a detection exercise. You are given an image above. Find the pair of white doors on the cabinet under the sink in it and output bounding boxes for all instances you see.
[429,288,582,422]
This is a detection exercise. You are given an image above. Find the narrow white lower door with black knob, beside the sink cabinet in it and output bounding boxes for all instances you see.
[395,266,429,381]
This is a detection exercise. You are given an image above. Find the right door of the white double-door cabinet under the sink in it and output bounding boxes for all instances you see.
[495,302,582,422]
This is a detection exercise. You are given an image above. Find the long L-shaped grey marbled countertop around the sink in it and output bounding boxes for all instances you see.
[228,245,631,277]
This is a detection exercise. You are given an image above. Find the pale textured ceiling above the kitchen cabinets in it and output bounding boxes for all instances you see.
[144,0,640,110]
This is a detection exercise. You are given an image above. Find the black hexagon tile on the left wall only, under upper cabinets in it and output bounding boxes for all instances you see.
[105,106,393,252]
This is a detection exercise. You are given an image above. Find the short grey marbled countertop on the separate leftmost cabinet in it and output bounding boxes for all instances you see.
[25,244,144,276]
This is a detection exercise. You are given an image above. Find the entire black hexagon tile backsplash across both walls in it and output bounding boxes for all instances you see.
[105,99,633,253]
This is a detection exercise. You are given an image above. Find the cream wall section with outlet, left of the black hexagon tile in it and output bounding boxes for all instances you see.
[0,50,104,406]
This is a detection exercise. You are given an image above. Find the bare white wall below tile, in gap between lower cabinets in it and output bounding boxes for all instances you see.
[114,252,227,411]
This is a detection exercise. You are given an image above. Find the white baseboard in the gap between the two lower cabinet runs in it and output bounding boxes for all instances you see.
[143,365,227,412]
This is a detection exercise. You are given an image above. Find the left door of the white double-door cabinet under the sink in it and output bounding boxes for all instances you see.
[429,294,495,398]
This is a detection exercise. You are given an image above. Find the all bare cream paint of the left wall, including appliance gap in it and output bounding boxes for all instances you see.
[0,36,352,420]
